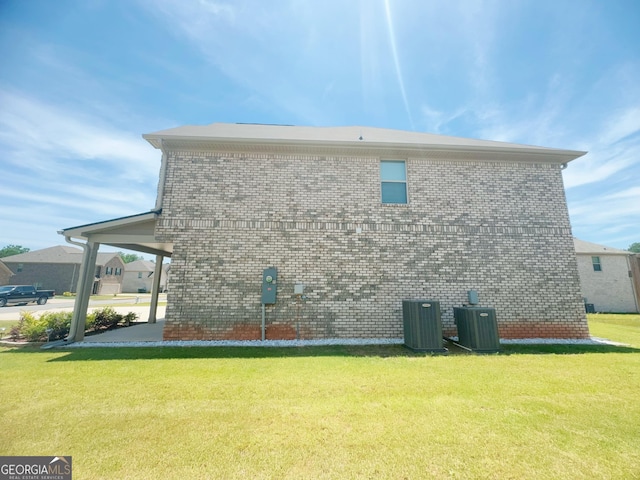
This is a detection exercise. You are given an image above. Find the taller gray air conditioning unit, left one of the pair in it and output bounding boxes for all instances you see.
[402,300,447,352]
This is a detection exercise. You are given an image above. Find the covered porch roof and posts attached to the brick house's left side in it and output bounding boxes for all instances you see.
[47,210,173,347]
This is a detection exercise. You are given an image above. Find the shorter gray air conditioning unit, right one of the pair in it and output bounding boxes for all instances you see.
[453,307,500,353]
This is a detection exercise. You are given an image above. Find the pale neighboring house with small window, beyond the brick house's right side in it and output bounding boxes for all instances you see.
[574,238,640,313]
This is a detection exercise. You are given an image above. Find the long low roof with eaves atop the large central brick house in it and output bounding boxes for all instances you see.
[143,123,586,163]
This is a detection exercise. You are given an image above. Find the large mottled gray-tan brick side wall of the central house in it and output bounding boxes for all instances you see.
[156,152,588,339]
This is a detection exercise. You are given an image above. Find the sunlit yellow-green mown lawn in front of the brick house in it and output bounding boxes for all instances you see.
[0,315,640,480]
